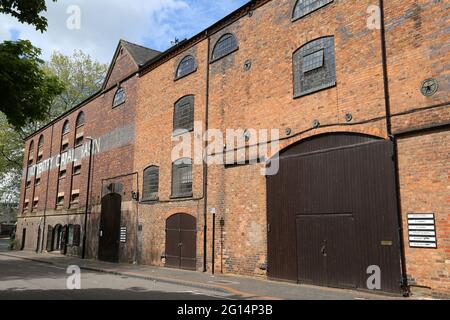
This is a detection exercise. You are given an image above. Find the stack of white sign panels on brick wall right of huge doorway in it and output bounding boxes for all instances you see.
[408,213,437,249]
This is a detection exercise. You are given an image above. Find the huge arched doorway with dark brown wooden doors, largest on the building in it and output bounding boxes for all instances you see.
[267,133,401,293]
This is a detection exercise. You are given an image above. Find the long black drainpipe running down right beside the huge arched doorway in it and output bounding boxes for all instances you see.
[379,0,410,296]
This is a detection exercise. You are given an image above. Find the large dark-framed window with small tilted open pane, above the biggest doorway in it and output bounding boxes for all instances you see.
[293,36,336,97]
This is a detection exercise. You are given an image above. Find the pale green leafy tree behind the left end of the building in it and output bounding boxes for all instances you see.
[0,51,107,202]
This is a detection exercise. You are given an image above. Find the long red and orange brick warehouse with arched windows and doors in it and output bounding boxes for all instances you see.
[17,0,450,296]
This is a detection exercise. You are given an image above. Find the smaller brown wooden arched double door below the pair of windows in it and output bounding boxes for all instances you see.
[166,213,197,270]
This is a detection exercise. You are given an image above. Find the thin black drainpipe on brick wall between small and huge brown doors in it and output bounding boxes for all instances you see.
[203,31,211,272]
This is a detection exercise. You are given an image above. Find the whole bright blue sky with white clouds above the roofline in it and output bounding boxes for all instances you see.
[0,0,248,63]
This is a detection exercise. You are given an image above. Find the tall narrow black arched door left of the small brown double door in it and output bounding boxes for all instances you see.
[98,193,122,262]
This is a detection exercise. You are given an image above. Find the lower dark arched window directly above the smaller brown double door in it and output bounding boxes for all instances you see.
[172,158,192,198]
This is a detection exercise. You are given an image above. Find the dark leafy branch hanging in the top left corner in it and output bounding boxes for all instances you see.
[0,0,56,32]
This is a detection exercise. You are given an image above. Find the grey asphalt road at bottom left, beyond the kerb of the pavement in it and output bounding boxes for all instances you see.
[0,250,237,300]
